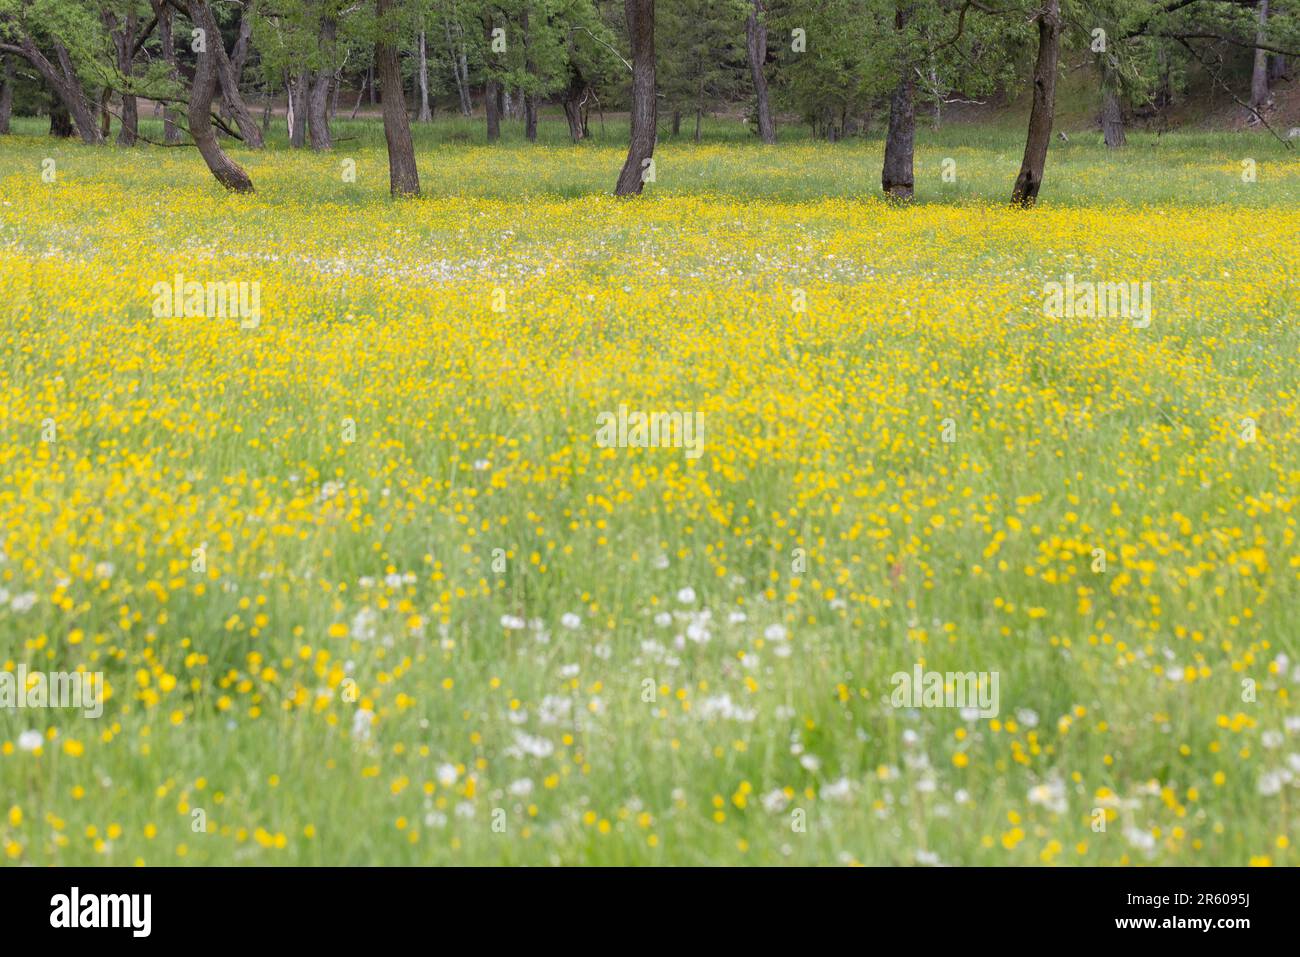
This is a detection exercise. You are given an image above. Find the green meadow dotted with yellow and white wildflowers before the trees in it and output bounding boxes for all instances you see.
[0,121,1300,865]
